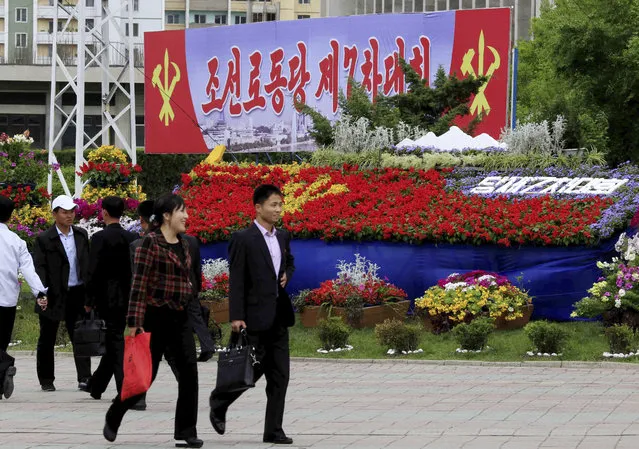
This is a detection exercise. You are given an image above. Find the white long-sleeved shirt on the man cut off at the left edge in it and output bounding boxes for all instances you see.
[0,223,46,307]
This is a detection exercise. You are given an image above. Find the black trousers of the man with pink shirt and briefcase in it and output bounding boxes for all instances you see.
[210,325,290,438]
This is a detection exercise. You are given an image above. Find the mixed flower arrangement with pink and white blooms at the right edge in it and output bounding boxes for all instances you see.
[571,233,639,329]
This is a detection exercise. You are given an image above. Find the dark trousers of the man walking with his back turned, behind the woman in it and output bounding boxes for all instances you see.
[90,307,127,395]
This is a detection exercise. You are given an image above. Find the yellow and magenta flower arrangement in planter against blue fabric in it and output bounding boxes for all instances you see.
[415,270,533,333]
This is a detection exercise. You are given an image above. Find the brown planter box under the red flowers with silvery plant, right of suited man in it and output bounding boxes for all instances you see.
[300,300,410,329]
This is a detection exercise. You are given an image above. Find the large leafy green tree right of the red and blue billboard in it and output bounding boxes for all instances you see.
[518,0,639,163]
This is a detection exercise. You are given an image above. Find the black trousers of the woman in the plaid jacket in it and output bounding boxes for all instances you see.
[106,306,198,440]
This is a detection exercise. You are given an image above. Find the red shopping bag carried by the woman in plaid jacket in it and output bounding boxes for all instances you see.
[120,332,153,401]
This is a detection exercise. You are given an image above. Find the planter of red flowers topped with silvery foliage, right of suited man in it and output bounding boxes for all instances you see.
[294,254,410,328]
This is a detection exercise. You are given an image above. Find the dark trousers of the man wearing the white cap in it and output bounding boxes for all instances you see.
[36,286,91,385]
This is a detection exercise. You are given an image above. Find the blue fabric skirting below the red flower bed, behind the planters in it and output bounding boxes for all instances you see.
[201,236,617,320]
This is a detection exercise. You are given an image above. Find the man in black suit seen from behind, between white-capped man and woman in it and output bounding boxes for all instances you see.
[84,196,138,399]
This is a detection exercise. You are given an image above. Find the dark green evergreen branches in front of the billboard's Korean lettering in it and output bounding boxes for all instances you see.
[296,60,487,146]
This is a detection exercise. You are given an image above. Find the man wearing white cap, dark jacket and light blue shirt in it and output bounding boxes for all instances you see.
[34,195,91,391]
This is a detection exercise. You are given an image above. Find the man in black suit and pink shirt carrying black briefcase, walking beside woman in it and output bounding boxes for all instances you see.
[210,184,295,444]
